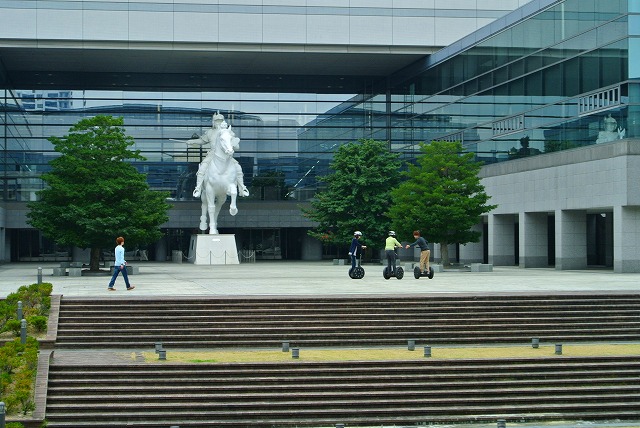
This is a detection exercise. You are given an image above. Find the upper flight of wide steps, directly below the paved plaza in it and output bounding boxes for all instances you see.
[56,295,640,349]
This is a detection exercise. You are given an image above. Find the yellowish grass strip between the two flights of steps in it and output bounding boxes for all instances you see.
[143,344,640,364]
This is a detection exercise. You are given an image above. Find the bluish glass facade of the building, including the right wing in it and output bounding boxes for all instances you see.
[0,0,640,268]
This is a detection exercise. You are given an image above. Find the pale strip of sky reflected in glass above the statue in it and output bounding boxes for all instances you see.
[73,91,354,126]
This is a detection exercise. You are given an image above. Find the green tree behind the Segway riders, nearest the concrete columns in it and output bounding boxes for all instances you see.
[388,141,497,265]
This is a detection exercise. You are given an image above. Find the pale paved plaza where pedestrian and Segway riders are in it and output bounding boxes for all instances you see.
[0,261,640,298]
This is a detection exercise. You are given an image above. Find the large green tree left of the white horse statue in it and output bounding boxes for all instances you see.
[27,116,169,271]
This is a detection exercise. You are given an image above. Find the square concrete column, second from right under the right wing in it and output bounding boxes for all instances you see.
[556,210,587,270]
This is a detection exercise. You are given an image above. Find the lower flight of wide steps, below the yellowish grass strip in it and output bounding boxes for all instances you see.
[47,356,640,428]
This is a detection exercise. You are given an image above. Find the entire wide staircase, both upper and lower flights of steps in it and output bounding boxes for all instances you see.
[46,294,640,428]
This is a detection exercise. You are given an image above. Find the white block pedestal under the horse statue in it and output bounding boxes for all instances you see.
[189,235,240,265]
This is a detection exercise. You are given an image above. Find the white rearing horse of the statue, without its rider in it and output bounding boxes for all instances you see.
[200,127,242,235]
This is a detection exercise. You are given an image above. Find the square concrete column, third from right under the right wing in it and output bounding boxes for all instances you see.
[518,213,549,268]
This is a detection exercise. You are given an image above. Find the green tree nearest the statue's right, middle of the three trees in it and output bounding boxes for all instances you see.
[304,140,401,252]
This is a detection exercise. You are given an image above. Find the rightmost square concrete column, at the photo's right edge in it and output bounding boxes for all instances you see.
[613,206,640,273]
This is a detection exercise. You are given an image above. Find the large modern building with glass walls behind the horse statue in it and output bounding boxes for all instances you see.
[0,0,640,272]
